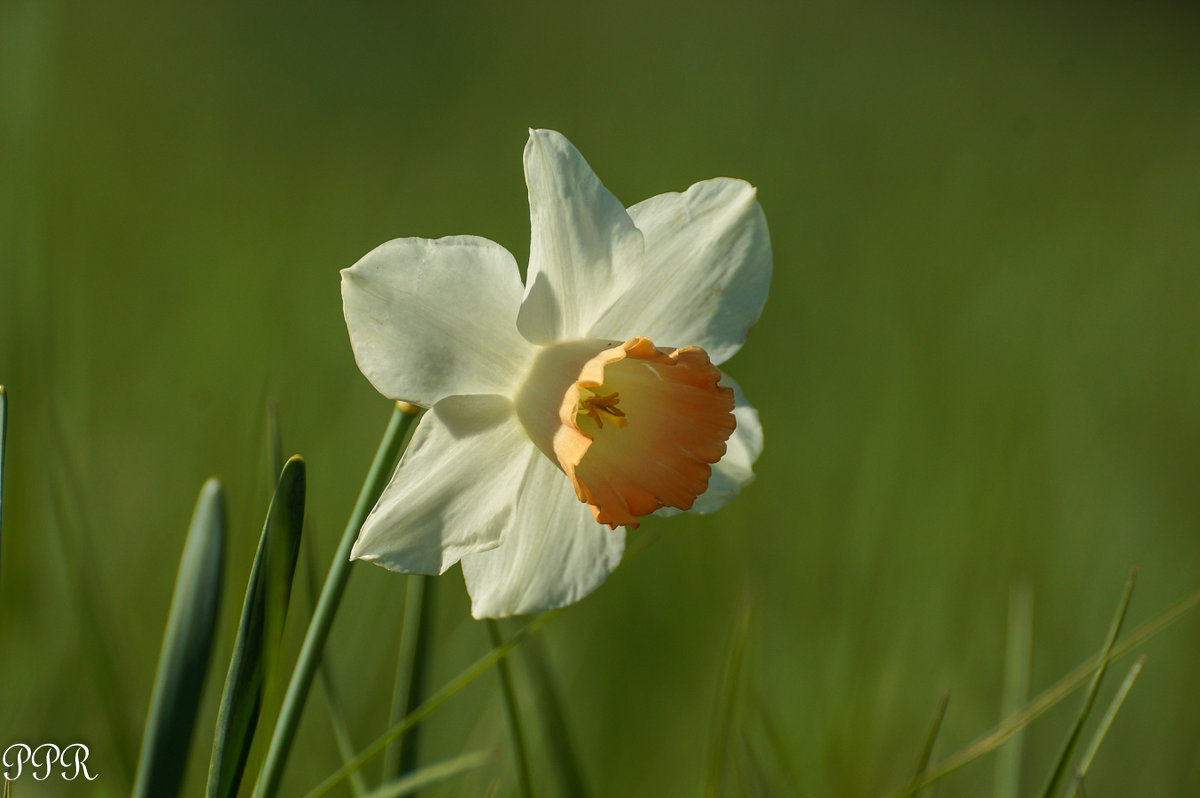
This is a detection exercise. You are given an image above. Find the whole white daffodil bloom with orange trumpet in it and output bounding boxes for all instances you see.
[342,131,770,618]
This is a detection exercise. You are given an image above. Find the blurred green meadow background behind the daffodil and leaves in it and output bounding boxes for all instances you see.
[0,0,1200,798]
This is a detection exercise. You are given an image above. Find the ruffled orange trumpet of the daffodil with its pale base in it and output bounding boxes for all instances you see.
[516,337,736,529]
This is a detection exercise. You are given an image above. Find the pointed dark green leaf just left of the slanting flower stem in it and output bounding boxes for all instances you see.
[206,457,306,798]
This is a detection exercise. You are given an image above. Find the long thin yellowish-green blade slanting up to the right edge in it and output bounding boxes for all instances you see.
[892,576,1200,798]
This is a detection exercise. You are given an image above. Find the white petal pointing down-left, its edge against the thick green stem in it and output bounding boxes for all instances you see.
[350,396,535,574]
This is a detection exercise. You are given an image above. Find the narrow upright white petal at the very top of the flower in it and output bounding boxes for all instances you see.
[517,131,642,344]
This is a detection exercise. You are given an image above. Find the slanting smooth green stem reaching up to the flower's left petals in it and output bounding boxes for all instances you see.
[254,404,416,798]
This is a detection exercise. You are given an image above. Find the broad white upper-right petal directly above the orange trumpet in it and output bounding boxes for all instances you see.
[588,178,772,364]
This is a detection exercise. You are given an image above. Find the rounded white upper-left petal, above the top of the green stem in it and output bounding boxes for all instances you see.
[342,235,533,407]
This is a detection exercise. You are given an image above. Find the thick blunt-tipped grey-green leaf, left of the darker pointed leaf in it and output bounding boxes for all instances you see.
[133,479,226,798]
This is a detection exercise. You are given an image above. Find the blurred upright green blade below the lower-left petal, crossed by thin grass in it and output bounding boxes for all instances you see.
[383,574,437,780]
